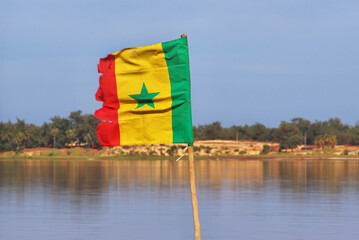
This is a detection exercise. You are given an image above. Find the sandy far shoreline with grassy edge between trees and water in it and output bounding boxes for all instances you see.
[0,140,359,160]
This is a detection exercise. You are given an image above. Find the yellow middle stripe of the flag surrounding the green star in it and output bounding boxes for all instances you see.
[112,44,173,145]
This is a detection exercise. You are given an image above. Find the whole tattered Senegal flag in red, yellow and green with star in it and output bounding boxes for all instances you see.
[95,37,193,146]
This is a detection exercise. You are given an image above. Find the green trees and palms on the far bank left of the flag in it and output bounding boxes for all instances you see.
[0,110,100,151]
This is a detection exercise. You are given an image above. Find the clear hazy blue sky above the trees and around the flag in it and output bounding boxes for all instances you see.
[0,0,359,127]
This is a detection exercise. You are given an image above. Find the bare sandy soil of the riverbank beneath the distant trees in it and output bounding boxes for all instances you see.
[0,140,359,157]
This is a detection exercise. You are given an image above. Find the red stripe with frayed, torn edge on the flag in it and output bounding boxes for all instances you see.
[95,54,120,146]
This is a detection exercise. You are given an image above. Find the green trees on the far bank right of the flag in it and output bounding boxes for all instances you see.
[193,117,359,149]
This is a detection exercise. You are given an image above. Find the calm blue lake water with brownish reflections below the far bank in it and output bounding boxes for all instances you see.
[0,159,359,240]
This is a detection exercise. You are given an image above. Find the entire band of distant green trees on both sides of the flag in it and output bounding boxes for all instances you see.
[0,111,359,151]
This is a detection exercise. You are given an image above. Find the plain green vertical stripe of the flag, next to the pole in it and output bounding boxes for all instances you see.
[162,38,193,144]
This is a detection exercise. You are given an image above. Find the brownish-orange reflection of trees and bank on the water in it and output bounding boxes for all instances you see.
[0,159,359,195]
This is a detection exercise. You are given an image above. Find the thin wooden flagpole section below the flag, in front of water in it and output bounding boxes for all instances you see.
[188,146,201,240]
